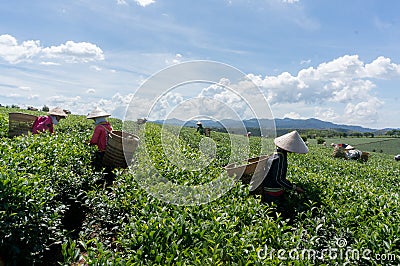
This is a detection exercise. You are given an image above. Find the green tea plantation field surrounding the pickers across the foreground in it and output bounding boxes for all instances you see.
[0,108,400,265]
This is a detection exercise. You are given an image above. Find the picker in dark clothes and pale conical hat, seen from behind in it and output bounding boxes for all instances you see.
[262,131,308,205]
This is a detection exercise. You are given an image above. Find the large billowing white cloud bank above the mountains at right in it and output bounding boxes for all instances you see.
[248,55,400,124]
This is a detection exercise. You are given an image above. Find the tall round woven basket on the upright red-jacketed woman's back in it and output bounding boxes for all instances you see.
[103,131,139,168]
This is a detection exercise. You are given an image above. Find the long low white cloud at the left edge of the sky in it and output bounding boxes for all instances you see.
[0,34,104,65]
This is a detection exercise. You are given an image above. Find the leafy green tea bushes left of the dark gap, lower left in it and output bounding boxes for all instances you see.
[0,108,96,264]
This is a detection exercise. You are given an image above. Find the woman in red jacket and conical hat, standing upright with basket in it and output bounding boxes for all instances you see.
[86,107,112,169]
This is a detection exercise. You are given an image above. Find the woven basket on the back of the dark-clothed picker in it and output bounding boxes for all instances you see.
[224,155,269,184]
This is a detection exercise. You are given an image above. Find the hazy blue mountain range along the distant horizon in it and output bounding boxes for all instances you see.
[154,118,396,133]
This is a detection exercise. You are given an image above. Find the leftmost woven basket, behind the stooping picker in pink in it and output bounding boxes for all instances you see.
[8,113,37,138]
